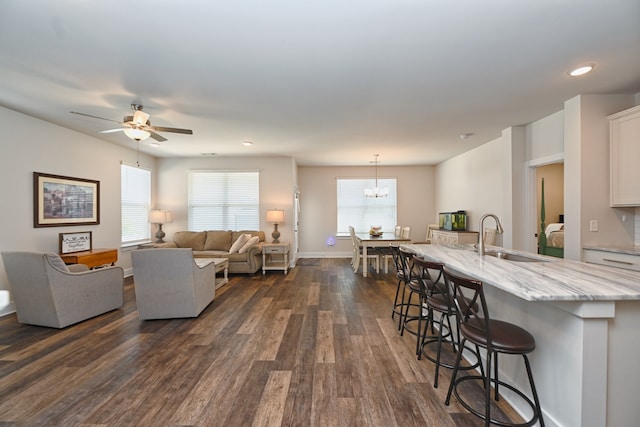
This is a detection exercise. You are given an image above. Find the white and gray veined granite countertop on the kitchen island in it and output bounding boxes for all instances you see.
[401,244,640,301]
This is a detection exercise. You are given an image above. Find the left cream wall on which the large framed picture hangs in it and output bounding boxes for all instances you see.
[0,107,155,315]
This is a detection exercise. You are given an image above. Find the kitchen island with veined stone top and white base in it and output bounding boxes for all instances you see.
[402,244,640,427]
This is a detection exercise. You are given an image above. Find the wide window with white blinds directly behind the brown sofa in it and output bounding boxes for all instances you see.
[188,171,260,231]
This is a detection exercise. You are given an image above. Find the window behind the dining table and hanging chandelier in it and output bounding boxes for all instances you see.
[337,178,397,235]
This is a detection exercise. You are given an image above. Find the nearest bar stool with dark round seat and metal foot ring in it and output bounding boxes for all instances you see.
[444,267,544,427]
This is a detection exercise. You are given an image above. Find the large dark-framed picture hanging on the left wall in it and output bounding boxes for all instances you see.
[33,172,100,228]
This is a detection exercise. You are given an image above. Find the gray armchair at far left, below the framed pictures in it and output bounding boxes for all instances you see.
[2,252,124,328]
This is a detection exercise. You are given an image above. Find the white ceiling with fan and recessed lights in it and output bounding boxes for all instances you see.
[0,0,640,165]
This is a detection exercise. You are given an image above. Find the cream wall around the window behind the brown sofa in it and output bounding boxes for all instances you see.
[157,156,297,258]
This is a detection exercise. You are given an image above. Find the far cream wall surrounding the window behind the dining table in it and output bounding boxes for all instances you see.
[298,166,437,257]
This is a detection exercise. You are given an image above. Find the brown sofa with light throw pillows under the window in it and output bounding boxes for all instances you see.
[152,230,265,274]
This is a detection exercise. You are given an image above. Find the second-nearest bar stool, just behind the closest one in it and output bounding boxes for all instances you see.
[413,258,484,388]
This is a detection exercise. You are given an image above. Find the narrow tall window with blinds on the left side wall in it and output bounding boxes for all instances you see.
[120,164,151,245]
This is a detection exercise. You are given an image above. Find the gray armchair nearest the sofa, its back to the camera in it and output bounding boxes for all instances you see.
[131,248,216,319]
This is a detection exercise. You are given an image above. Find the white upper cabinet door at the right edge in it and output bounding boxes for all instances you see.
[609,106,640,206]
